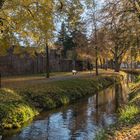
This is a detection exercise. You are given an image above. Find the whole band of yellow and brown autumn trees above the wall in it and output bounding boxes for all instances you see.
[0,0,140,77]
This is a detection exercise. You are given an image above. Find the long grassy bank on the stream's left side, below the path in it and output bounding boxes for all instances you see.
[0,76,118,129]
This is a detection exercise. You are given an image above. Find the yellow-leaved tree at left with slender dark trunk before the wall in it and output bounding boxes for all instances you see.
[0,0,54,77]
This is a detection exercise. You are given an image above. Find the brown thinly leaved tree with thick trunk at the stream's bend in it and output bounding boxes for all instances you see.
[103,0,139,72]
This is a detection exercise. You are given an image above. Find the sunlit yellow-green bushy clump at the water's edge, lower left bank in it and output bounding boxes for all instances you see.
[0,102,38,128]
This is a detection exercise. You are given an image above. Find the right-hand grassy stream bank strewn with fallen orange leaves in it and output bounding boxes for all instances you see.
[97,77,140,140]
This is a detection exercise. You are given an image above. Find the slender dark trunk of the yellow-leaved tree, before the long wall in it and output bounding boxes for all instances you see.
[46,43,50,78]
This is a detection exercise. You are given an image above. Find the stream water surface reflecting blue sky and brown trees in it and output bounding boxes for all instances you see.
[3,84,129,140]
